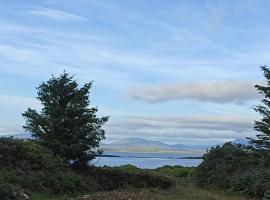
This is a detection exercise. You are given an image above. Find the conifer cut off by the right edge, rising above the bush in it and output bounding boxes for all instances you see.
[249,66,270,149]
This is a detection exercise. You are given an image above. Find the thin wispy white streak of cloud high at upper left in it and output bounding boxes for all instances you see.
[28,8,88,21]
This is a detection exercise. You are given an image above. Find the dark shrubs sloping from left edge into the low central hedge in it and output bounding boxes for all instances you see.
[0,138,175,200]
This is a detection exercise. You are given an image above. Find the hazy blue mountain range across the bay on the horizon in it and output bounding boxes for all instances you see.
[101,138,207,150]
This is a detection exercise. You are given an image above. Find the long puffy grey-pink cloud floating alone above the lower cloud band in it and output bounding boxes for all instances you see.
[128,80,258,103]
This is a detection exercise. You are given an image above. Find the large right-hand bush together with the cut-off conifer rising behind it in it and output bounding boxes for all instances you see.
[197,66,270,200]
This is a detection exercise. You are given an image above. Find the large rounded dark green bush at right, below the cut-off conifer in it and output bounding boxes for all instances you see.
[197,143,270,198]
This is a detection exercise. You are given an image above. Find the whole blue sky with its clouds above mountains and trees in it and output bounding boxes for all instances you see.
[0,0,270,144]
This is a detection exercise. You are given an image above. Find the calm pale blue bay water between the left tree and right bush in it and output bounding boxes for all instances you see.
[93,152,202,169]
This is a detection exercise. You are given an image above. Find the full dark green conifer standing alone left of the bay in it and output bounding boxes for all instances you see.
[22,72,108,166]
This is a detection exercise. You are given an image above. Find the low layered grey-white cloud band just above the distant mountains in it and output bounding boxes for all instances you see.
[106,115,254,143]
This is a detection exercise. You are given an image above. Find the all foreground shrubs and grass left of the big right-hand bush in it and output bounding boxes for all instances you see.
[0,138,249,200]
